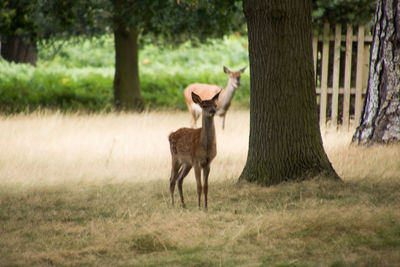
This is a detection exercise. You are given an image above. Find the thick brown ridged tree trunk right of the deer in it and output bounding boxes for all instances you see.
[239,0,340,185]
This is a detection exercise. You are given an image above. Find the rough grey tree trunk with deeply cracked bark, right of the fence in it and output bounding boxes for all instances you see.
[353,0,400,145]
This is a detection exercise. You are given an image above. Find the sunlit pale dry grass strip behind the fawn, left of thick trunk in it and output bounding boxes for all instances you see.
[0,112,248,185]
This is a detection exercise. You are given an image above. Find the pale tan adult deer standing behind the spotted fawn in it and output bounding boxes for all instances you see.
[183,66,246,129]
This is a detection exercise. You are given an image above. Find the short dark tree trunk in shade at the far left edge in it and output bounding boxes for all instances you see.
[1,36,37,66]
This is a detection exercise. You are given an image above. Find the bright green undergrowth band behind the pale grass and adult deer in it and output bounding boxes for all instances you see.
[0,36,249,113]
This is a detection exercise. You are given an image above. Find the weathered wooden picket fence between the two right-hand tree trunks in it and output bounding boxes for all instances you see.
[313,24,372,130]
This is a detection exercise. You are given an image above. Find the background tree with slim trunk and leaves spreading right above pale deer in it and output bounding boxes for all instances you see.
[111,0,239,110]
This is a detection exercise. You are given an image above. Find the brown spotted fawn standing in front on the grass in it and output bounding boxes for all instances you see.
[168,92,220,209]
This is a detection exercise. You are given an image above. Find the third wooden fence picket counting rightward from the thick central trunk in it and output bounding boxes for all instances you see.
[331,24,342,129]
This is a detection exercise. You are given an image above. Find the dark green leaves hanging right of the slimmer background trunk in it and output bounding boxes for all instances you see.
[133,0,245,43]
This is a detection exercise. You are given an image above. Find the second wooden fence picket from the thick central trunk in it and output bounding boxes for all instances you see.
[319,23,329,129]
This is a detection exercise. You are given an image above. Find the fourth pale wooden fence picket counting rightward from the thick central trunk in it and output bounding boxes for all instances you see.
[343,24,353,131]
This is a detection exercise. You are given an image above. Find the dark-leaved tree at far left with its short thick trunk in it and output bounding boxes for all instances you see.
[0,0,107,65]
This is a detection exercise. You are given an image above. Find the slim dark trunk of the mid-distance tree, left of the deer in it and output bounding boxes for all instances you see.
[114,27,143,111]
